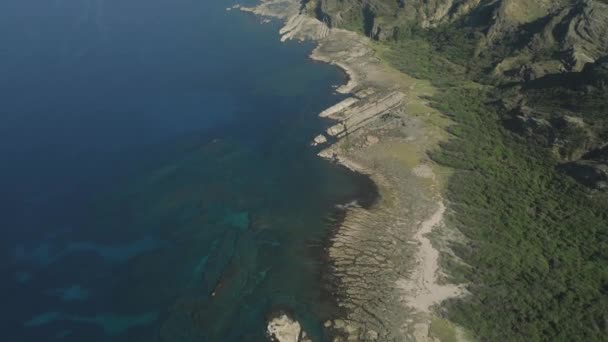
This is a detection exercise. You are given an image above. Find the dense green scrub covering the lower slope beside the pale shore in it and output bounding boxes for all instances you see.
[381,28,608,341]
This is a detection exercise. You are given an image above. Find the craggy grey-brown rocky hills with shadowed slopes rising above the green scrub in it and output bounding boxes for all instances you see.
[303,0,608,184]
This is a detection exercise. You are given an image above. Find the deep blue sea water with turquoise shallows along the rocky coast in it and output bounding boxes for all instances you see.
[0,0,373,342]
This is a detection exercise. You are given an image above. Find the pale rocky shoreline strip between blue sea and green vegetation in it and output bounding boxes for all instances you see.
[240,0,464,341]
